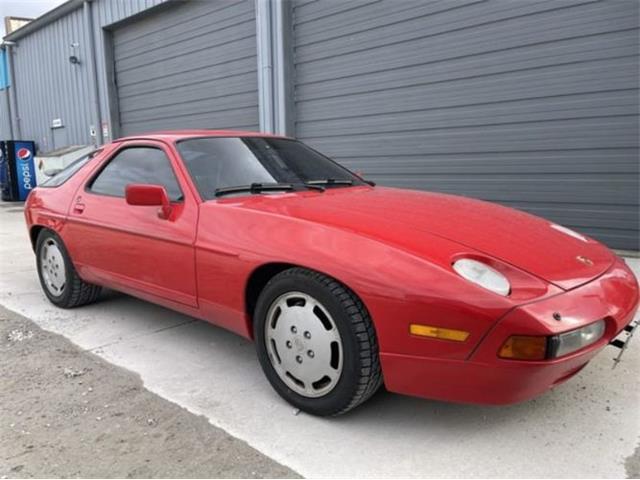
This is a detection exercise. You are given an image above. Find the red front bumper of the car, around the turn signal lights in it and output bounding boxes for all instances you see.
[380,259,638,405]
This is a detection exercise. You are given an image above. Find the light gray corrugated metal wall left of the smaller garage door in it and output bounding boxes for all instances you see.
[6,0,162,151]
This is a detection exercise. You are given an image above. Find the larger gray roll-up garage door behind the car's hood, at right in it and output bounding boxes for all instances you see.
[294,0,639,249]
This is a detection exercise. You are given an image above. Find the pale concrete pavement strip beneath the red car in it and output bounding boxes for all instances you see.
[0,201,640,478]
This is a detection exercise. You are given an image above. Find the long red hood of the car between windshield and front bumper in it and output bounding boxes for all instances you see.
[230,187,614,290]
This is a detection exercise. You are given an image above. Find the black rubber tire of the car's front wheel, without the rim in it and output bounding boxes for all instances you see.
[253,268,382,416]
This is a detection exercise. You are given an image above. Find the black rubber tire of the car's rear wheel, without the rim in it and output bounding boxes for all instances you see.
[36,229,101,308]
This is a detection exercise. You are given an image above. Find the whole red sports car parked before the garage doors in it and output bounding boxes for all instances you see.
[25,130,638,415]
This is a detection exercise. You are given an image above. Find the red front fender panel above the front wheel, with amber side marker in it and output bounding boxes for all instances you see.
[196,202,556,359]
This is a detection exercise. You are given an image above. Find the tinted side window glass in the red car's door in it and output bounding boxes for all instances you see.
[90,147,182,201]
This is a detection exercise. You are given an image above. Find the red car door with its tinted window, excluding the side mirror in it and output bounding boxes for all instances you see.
[68,141,198,307]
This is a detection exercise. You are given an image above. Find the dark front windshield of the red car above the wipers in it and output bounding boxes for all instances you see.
[178,137,364,200]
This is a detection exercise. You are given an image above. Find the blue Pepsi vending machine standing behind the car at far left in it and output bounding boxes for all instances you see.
[0,140,36,201]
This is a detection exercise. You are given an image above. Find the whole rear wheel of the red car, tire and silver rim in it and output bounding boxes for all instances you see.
[36,230,101,308]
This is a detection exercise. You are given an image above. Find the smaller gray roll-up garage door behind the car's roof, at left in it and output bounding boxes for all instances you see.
[113,0,258,135]
